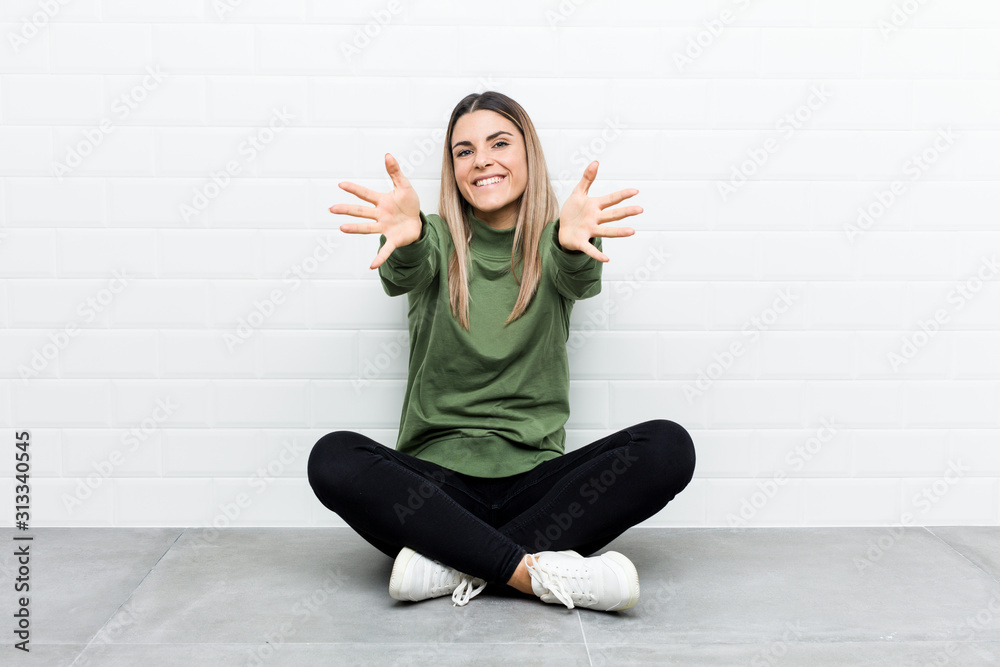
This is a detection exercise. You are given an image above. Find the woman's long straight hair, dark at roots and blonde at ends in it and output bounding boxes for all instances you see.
[438,90,559,331]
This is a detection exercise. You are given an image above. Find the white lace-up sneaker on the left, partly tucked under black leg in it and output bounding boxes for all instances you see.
[389,547,486,607]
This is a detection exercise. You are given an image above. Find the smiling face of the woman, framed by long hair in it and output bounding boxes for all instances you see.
[451,109,528,229]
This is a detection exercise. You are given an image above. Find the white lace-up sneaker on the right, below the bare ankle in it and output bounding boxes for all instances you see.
[525,551,639,611]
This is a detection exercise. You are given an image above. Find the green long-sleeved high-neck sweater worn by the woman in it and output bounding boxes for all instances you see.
[378,211,603,477]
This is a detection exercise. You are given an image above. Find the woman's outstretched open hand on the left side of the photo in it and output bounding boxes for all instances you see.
[330,153,422,269]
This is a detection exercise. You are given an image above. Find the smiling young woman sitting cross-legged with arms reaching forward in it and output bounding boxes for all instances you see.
[308,91,695,611]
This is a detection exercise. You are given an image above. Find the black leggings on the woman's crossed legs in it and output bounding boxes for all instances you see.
[308,419,695,584]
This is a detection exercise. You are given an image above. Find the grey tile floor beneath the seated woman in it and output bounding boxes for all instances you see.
[0,527,1000,667]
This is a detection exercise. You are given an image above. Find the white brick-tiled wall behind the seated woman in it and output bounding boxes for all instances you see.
[0,0,1000,526]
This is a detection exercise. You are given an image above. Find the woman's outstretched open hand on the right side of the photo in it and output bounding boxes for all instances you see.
[559,160,642,262]
